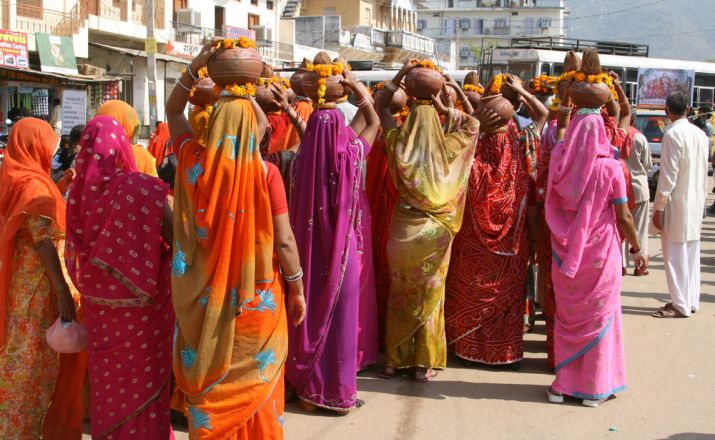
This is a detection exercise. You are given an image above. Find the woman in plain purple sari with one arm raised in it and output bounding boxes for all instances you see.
[286,74,379,412]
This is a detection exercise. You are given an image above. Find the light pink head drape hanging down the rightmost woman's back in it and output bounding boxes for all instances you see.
[546,114,613,277]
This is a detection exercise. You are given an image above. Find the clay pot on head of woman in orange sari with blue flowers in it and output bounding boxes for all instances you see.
[208,47,263,87]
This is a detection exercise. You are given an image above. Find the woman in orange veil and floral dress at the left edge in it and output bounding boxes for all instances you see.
[0,118,81,439]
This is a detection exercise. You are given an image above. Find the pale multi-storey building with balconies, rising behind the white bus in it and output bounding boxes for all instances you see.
[416,0,566,69]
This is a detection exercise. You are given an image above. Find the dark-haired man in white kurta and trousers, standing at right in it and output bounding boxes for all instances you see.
[653,92,708,318]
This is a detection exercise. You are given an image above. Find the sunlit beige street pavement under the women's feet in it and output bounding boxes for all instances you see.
[87,210,715,440]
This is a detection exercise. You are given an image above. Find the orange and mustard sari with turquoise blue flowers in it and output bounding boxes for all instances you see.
[172,98,287,439]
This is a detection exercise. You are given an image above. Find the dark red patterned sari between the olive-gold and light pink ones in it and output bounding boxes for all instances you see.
[445,121,531,364]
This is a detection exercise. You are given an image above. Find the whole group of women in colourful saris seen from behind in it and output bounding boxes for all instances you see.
[0,40,647,440]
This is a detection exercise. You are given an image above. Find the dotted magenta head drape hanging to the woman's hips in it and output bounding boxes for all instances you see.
[65,116,167,302]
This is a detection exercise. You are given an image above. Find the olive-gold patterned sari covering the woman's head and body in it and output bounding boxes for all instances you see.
[385,105,479,368]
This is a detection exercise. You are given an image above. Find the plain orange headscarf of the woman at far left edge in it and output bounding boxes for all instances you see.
[0,118,65,351]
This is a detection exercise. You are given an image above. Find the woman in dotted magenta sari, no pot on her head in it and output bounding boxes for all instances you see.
[65,116,174,440]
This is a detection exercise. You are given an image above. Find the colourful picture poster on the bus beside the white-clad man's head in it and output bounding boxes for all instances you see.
[636,68,695,110]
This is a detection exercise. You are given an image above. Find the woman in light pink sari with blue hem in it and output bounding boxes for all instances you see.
[545,87,648,407]
